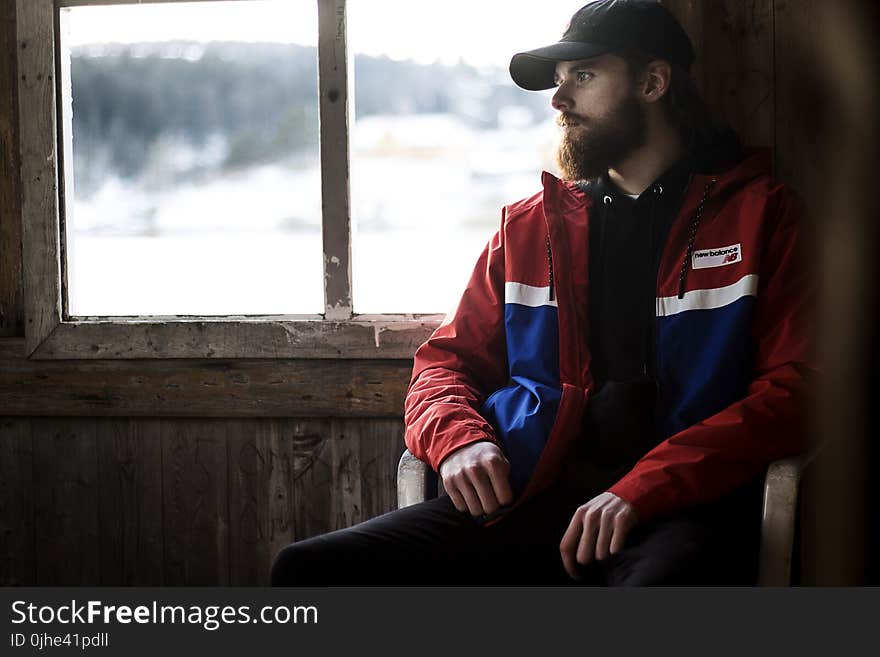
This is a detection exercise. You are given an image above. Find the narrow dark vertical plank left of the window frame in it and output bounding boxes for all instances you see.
[0,0,24,336]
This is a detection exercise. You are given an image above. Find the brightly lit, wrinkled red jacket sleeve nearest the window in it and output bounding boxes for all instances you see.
[404,218,507,470]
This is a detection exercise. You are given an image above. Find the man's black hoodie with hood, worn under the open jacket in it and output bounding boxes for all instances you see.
[568,131,742,469]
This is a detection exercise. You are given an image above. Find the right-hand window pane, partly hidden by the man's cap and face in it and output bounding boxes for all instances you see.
[349,0,577,313]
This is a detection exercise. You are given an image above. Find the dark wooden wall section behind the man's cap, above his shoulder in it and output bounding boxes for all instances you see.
[663,0,824,201]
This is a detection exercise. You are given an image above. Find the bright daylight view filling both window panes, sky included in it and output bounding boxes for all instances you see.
[60,0,571,316]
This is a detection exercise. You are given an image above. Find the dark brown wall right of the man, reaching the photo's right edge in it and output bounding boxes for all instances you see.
[664,0,880,585]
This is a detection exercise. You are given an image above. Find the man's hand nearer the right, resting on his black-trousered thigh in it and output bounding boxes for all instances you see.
[559,492,638,579]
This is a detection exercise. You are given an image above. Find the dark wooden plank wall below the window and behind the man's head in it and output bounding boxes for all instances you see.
[0,0,852,585]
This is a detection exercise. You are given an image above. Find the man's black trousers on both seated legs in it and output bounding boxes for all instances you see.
[272,464,762,586]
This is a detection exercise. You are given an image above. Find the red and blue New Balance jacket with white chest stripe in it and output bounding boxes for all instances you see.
[405,150,813,520]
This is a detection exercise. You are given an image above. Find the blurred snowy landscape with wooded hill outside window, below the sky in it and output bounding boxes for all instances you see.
[67,37,556,316]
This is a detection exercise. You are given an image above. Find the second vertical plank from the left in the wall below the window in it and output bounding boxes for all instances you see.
[31,418,100,586]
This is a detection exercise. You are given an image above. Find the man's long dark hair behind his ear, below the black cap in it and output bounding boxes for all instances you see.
[614,50,724,153]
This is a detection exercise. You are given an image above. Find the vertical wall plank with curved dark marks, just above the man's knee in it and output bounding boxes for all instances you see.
[281,419,335,540]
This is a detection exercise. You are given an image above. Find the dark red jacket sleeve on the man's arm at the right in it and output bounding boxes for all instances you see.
[609,187,815,520]
